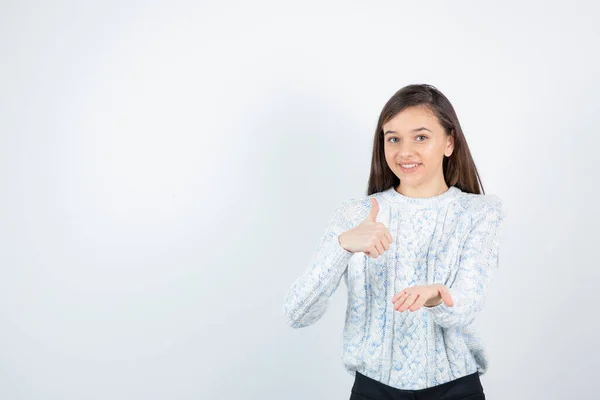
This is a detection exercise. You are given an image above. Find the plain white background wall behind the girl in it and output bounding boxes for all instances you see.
[0,1,600,400]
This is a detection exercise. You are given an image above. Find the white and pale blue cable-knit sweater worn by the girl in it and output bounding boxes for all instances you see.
[283,186,506,390]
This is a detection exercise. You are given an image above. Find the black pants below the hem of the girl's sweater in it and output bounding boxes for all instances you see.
[350,371,485,400]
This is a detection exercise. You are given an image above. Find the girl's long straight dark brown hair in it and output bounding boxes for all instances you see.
[367,84,485,196]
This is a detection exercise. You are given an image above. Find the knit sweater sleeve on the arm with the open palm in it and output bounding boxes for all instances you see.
[423,195,506,328]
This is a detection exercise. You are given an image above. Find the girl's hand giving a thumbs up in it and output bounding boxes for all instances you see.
[339,197,392,258]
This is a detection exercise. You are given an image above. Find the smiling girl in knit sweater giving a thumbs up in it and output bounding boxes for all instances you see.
[284,85,505,400]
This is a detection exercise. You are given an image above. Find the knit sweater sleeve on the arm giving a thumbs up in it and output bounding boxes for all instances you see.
[283,202,354,328]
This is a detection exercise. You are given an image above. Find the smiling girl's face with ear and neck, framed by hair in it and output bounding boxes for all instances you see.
[383,106,454,189]
